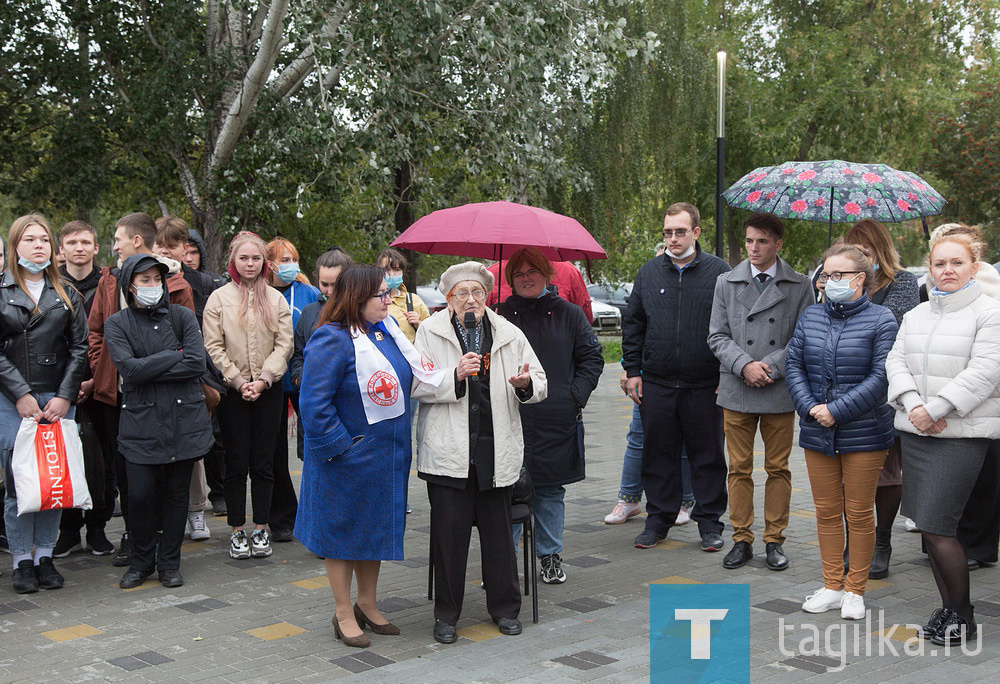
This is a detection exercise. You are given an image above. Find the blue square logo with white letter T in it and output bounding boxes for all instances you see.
[649,584,754,684]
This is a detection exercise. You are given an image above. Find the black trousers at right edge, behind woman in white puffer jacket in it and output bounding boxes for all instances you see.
[956,440,1000,563]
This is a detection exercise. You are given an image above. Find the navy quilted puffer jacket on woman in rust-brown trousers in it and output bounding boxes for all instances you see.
[785,295,898,456]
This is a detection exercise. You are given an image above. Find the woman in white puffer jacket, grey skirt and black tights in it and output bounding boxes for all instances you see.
[886,234,1000,645]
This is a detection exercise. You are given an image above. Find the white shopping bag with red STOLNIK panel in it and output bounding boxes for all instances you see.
[7,418,93,515]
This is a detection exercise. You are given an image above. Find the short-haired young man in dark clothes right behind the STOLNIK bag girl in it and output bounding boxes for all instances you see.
[52,221,115,558]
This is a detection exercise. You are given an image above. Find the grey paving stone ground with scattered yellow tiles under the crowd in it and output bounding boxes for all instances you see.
[0,365,1000,684]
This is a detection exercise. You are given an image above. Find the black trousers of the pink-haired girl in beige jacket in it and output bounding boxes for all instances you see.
[216,384,285,527]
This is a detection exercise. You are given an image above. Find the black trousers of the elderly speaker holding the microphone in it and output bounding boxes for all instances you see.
[427,477,521,625]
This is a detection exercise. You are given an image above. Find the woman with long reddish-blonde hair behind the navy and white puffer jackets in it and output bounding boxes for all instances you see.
[844,219,920,579]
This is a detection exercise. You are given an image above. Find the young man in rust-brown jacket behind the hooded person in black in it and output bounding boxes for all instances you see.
[87,212,194,567]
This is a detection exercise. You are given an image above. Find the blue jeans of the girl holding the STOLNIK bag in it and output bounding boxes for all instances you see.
[0,392,76,556]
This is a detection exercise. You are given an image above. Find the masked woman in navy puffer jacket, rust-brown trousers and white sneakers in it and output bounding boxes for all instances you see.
[785,245,897,620]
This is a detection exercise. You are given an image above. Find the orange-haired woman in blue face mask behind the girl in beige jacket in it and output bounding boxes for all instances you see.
[267,236,320,542]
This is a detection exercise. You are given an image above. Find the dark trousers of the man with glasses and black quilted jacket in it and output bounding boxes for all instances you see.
[639,382,729,535]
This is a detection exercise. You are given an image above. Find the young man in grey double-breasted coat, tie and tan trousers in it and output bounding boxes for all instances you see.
[708,214,813,570]
